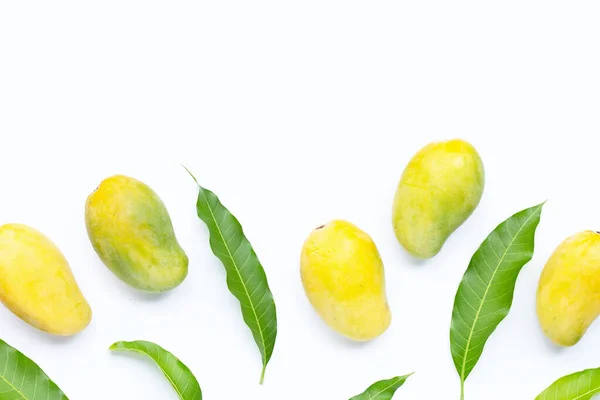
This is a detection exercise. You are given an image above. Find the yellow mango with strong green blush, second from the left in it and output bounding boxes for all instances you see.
[85,175,188,292]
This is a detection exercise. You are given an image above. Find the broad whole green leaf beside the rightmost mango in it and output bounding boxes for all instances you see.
[450,203,544,399]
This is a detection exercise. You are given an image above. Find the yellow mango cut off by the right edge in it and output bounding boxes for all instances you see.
[536,231,600,347]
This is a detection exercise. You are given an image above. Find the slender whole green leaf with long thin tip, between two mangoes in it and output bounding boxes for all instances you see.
[188,170,277,385]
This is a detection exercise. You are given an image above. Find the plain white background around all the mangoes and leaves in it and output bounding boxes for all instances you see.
[0,0,600,400]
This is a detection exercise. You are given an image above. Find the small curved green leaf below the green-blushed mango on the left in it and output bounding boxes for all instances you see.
[110,340,202,400]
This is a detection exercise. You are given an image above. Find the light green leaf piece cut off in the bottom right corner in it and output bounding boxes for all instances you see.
[535,368,600,400]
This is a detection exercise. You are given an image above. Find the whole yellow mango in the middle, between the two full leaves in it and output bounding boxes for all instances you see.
[300,220,391,341]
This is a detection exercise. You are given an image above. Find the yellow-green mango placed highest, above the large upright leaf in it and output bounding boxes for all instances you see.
[392,139,485,259]
